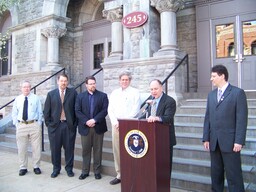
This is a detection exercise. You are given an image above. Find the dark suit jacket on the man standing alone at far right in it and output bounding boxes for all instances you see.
[203,84,248,152]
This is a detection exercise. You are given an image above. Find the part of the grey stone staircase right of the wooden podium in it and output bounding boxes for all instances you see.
[172,93,256,192]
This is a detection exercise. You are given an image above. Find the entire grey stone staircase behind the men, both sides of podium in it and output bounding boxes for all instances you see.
[0,93,256,192]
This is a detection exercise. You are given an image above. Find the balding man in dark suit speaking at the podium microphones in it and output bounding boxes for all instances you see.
[147,79,176,177]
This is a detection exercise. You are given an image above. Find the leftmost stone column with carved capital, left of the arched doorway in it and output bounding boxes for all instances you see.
[41,25,67,68]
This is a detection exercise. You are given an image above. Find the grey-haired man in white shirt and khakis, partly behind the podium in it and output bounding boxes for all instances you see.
[108,71,140,185]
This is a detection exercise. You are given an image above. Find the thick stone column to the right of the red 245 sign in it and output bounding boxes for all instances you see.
[151,0,184,54]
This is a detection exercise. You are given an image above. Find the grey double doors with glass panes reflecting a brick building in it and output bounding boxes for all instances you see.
[211,13,256,91]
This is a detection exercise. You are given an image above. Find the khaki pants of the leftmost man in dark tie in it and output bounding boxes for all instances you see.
[16,122,42,169]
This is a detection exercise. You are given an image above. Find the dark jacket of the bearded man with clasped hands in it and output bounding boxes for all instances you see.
[75,90,108,135]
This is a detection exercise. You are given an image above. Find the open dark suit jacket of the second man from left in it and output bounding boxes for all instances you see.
[44,88,77,133]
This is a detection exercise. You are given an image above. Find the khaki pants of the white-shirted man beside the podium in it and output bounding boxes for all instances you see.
[112,126,121,179]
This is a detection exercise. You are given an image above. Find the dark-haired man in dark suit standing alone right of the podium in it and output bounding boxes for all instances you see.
[203,65,248,192]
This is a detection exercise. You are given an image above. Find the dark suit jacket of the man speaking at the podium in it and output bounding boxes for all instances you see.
[148,93,176,146]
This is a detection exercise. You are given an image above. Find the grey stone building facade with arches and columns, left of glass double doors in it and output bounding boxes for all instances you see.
[0,0,197,115]
